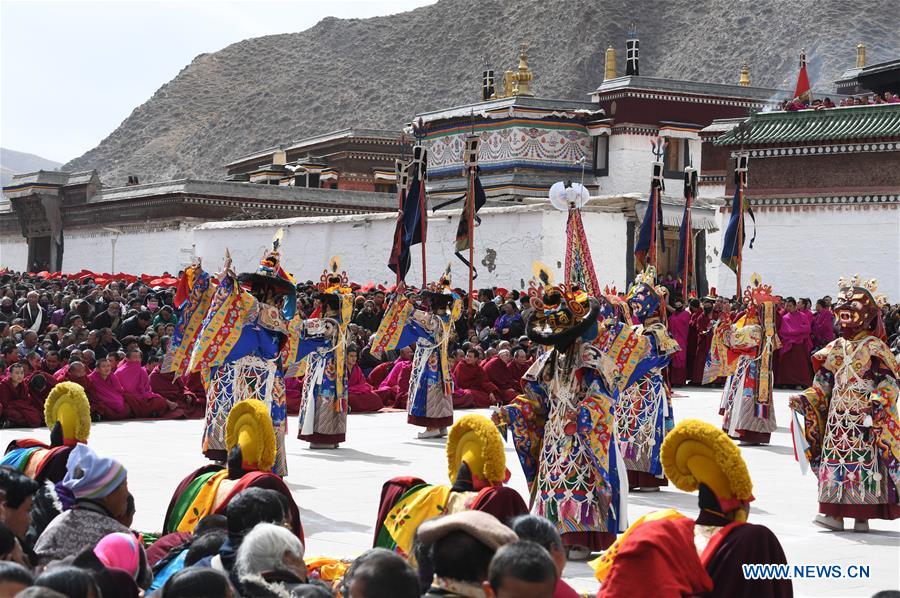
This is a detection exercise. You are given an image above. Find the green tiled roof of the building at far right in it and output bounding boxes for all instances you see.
[714,104,900,150]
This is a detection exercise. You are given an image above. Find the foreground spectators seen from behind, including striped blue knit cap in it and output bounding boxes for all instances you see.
[0,445,578,598]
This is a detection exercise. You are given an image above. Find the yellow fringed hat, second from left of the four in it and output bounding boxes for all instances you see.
[225,399,275,471]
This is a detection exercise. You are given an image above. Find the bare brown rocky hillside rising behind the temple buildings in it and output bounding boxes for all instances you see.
[65,0,900,184]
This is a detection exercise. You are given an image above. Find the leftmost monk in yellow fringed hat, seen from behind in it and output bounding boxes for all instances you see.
[0,382,91,484]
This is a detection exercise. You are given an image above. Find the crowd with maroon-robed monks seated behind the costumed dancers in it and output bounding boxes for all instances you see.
[0,273,900,427]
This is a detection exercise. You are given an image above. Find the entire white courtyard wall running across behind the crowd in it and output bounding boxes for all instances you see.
[0,204,900,301]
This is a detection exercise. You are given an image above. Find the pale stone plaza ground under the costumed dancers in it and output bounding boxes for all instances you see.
[0,388,900,597]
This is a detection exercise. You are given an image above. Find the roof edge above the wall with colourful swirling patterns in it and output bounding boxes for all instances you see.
[412,96,604,133]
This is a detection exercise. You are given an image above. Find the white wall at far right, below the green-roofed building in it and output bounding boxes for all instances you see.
[710,204,900,302]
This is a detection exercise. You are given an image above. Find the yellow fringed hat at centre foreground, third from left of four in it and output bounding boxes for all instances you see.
[447,413,506,484]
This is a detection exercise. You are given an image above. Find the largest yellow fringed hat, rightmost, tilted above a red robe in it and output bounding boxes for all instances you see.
[660,419,753,516]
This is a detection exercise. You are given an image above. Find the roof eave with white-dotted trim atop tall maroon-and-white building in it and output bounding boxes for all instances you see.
[591,75,792,108]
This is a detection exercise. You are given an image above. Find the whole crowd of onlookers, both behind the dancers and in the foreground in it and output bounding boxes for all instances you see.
[0,273,900,598]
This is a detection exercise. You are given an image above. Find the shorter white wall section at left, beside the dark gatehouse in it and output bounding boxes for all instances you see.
[62,221,200,274]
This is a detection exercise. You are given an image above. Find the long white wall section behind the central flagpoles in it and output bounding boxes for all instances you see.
[194,205,625,288]
